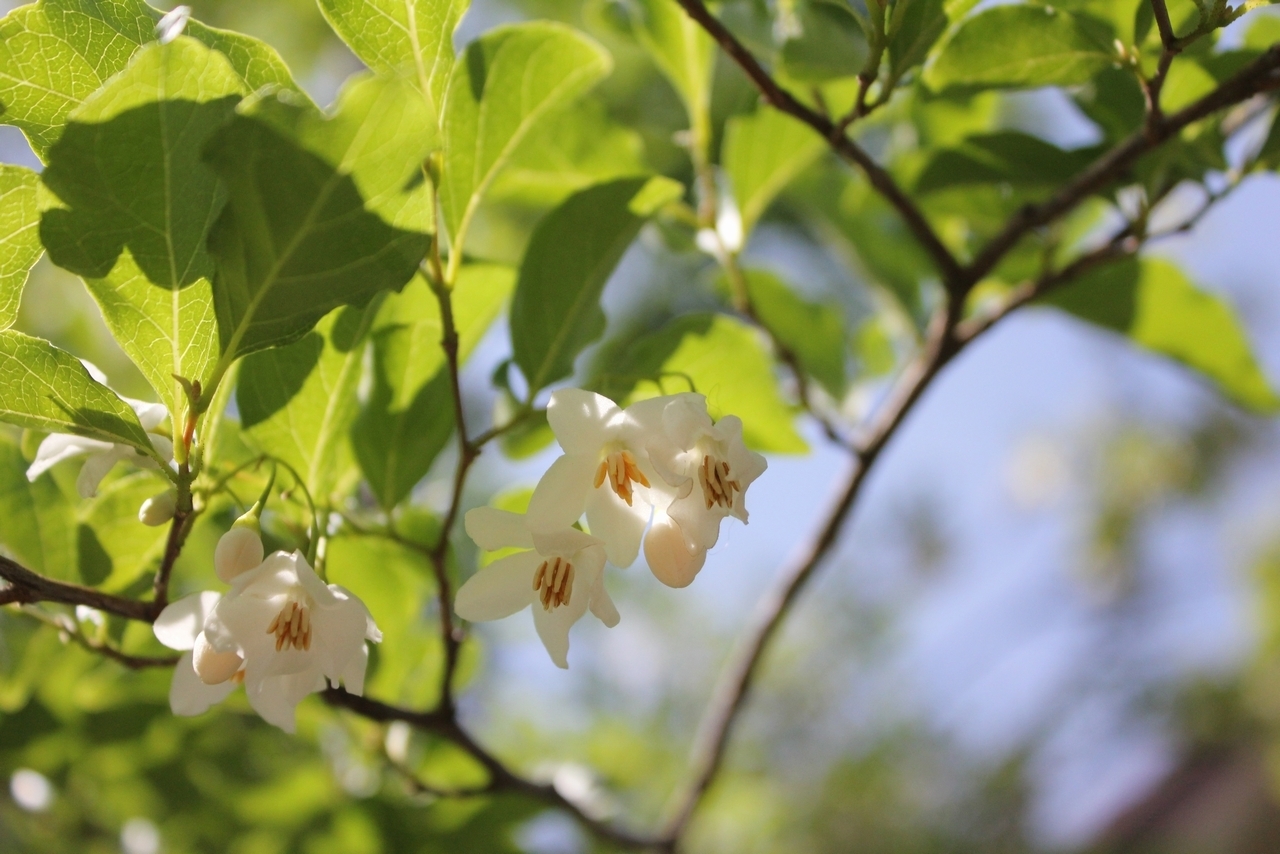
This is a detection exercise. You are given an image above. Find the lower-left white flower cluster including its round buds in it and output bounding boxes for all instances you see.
[155,525,383,732]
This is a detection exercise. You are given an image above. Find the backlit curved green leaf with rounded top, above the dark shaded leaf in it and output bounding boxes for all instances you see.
[440,23,612,262]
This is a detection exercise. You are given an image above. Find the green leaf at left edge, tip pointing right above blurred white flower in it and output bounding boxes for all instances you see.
[0,329,155,456]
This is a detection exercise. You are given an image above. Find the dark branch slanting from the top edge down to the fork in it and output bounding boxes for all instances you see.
[676,0,963,288]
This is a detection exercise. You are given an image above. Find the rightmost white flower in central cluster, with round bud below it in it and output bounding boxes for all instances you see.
[645,393,768,586]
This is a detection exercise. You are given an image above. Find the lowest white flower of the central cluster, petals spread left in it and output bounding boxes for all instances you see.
[453,507,618,668]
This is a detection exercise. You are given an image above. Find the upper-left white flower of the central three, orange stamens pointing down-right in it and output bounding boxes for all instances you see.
[529,388,678,566]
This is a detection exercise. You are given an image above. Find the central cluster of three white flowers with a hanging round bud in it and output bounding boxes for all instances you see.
[454,388,765,667]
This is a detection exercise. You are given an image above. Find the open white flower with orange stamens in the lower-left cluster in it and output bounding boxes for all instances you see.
[197,545,383,732]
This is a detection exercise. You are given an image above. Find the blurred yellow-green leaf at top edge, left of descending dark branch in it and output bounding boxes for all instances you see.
[631,0,716,135]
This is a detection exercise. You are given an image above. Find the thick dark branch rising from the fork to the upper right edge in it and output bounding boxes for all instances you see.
[963,45,1280,291]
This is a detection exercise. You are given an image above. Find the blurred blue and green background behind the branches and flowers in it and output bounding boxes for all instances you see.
[0,0,1280,854]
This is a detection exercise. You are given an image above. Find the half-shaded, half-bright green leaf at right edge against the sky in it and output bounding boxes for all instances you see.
[1044,259,1280,414]
